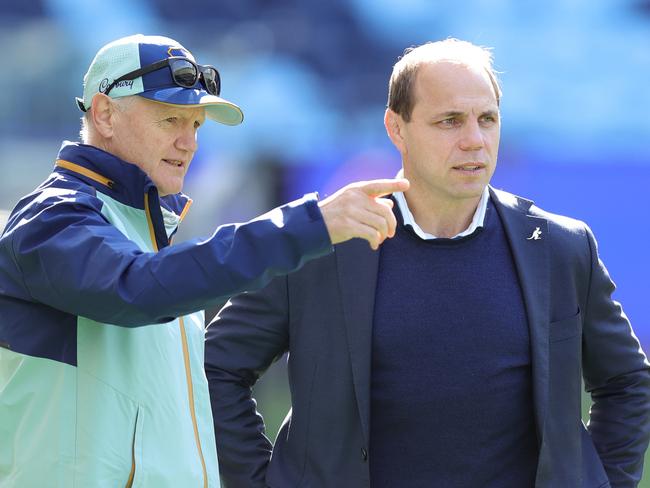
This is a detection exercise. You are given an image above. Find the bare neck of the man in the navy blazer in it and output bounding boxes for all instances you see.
[404,186,482,238]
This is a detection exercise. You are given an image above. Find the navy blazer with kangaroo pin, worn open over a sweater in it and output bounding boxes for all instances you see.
[206,189,650,488]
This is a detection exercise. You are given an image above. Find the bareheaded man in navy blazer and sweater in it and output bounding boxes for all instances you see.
[206,39,650,488]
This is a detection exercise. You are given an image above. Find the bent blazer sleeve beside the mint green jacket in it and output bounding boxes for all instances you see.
[200,277,289,488]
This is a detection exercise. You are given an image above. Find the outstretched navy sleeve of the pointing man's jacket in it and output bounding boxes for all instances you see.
[2,189,332,327]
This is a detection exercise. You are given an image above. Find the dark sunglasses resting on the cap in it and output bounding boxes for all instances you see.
[77,56,221,112]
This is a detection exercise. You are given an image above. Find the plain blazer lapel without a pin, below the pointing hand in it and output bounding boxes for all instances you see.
[335,239,379,443]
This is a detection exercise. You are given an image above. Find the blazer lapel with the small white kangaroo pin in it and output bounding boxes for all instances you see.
[490,188,550,443]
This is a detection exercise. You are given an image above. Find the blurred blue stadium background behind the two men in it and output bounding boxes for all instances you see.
[0,0,650,487]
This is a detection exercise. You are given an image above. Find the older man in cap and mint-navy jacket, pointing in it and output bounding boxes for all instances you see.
[0,35,408,488]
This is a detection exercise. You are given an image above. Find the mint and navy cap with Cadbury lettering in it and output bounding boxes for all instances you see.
[77,34,244,125]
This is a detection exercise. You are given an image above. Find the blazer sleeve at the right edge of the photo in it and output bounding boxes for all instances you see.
[582,224,650,488]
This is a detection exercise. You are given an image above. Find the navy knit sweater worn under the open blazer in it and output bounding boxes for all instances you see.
[369,206,538,488]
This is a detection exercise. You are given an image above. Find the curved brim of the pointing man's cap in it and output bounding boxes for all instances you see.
[138,86,244,125]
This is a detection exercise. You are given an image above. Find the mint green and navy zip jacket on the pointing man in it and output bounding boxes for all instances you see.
[0,139,331,488]
